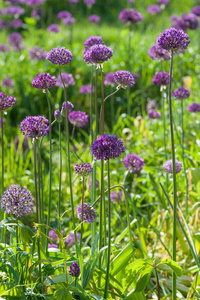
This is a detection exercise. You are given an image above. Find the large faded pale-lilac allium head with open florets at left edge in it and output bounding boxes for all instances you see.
[0,184,34,217]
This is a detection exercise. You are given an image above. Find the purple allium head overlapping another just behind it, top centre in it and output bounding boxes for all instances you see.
[83,45,113,65]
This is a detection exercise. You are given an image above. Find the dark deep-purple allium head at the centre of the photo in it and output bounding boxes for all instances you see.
[90,134,125,160]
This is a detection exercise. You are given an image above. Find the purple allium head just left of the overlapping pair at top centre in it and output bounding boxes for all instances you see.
[46,47,73,65]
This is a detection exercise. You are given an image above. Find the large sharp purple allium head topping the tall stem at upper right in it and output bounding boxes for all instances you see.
[157,27,190,50]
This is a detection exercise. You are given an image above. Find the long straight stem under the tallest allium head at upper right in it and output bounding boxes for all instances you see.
[169,50,177,300]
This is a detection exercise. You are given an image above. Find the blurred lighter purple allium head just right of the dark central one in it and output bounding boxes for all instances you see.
[122,154,144,173]
